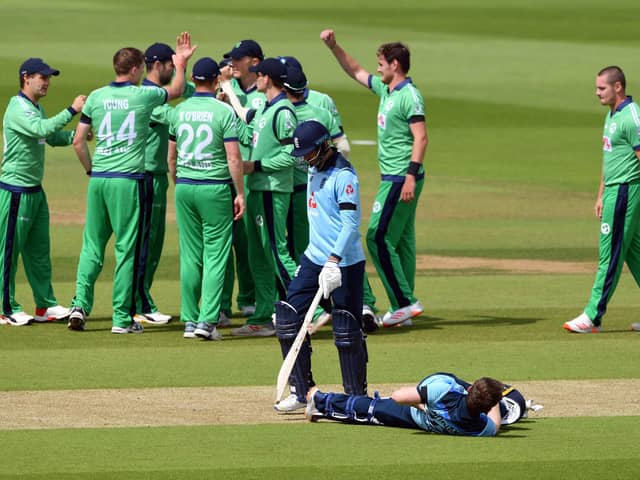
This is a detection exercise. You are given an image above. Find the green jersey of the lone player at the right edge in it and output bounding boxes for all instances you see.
[602,97,640,186]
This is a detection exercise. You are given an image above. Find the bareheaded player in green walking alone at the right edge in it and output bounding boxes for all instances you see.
[563,66,640,333]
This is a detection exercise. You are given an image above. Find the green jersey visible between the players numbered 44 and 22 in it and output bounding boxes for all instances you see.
[142,78,196,174]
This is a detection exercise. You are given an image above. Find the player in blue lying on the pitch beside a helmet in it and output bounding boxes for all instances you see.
[306,373,542,437]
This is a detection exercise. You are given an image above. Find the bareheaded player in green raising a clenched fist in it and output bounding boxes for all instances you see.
[320,30,427,327]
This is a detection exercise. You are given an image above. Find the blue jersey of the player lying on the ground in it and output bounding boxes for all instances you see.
[411,373,497,437]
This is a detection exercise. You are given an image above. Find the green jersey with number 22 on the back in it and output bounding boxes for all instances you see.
[169,92,239,180]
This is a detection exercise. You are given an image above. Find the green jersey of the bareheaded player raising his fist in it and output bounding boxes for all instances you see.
[369,75,424,176]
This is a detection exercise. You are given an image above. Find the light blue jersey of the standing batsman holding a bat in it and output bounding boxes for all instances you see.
[304,154,365,267]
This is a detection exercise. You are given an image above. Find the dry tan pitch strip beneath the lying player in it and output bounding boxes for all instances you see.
[0,379,640,430]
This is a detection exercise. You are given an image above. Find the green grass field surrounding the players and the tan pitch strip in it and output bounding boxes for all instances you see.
[0,0,640,479]
